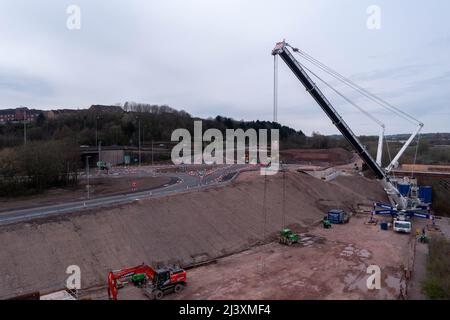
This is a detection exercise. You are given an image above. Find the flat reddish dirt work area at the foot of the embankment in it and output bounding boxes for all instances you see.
[111,215,411,300]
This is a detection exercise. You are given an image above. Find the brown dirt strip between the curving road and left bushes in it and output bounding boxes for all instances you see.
[0,176,170,212]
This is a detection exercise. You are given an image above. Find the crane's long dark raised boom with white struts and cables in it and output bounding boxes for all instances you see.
[272,41,423,210]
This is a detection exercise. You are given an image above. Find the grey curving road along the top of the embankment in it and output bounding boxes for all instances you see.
[0,165,252,225]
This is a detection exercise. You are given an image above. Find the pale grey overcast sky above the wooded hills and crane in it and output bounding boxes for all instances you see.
[0,0,450,134]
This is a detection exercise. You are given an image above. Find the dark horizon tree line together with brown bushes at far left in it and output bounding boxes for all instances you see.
[0,102,356,196]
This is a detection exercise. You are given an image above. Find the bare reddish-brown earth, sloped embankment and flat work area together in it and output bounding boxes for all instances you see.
[0,157,448,299]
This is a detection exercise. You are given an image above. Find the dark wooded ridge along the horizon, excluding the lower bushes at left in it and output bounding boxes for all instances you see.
[0,102,352,149]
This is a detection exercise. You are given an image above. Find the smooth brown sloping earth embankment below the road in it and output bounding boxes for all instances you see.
[0,173,383,298]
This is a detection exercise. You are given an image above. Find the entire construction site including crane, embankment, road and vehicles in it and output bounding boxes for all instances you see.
[0,21,450,300]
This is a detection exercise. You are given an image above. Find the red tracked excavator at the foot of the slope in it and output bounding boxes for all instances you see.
[108,264,186,300]
